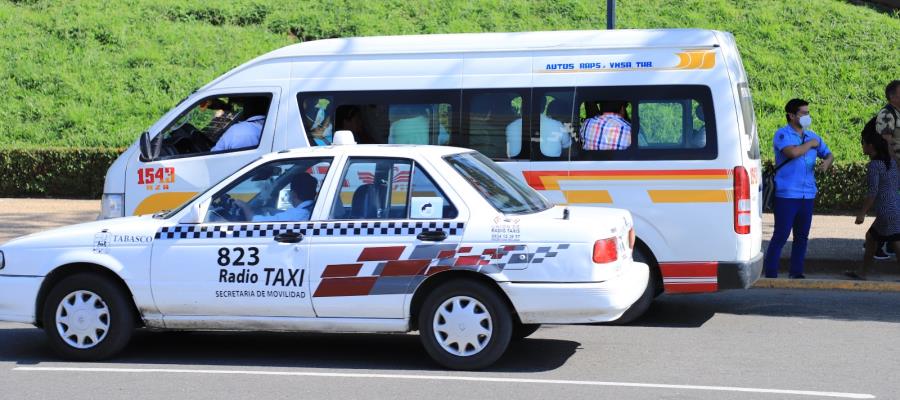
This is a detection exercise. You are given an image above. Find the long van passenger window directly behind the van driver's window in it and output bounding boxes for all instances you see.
[297,90,460,146]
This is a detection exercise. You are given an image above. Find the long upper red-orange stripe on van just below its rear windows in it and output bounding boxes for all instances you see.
[522,169,730,190]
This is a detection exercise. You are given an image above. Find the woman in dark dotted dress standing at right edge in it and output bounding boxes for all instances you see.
[844,130,900,279]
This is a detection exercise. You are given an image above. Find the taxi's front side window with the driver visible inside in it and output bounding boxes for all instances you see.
[204,158,331,222]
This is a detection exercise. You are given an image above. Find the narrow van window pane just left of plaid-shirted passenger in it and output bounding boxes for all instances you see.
[531,89,575,161]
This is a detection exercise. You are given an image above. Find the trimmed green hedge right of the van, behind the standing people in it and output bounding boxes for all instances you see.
[763,160,867,212]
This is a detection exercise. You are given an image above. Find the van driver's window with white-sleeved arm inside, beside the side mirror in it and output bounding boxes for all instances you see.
[152,95,272,160]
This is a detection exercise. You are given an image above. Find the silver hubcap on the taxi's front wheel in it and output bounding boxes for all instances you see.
[56,290,109,349]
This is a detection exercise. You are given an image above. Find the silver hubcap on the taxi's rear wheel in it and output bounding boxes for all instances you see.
[432,296,494,357]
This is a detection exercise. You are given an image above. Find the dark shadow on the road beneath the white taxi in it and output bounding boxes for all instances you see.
[0,326,581,372]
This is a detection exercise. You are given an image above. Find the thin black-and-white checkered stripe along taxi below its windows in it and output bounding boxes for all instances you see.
[156,221,465,240]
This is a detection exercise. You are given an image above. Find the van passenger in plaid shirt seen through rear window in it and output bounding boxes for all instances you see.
[580,101,631,151]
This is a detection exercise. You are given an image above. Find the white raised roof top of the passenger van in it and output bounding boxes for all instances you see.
[256,29,719,61]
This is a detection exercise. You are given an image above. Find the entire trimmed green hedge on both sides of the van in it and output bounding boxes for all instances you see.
[0,148,866,211]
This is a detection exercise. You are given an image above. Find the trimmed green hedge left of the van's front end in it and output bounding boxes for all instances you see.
[0,148,124,199]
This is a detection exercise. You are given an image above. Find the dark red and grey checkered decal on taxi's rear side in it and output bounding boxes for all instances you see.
[313,244,569,297]
